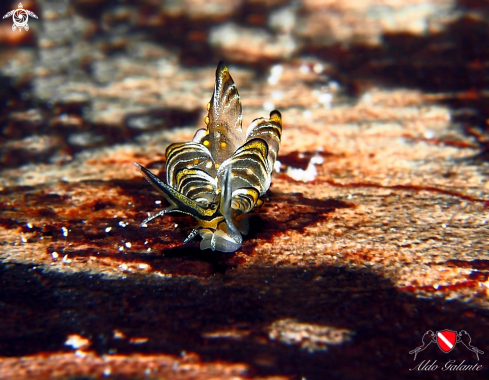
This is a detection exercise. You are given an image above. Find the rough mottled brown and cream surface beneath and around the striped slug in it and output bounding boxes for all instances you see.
[0,0,489,379]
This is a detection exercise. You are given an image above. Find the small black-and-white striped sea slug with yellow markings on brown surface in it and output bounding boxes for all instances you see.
[136,62,282,252]
